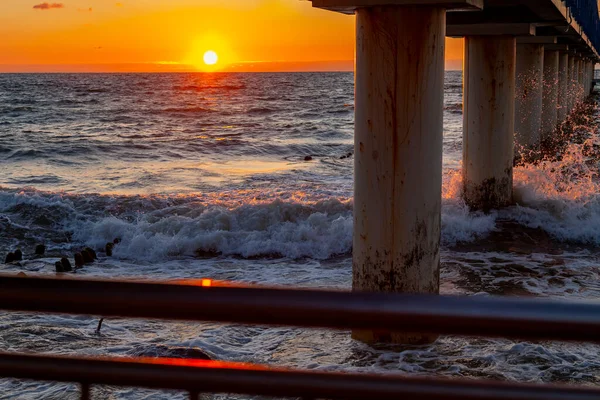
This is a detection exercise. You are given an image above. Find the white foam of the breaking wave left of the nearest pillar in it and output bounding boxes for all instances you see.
[73,200,352,261]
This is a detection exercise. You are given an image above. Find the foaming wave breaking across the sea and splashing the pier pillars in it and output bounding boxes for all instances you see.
[0,126,600,262]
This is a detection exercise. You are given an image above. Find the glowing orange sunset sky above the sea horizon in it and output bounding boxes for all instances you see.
[0,0,462,72]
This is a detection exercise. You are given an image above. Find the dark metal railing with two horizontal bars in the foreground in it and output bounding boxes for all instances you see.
[0,276,600,400]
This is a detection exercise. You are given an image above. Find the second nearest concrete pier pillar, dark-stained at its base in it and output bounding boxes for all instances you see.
[463,36,516,211]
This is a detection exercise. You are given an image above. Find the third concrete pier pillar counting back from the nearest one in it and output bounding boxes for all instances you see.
[515,44,544,161]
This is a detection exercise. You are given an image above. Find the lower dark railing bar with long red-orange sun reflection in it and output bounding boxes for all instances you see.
[0,354,600,400]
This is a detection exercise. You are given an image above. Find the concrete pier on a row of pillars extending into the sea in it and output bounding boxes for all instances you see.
[312,0,600,343]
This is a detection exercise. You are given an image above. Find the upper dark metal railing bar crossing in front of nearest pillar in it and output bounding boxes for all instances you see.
[0,276,600,342]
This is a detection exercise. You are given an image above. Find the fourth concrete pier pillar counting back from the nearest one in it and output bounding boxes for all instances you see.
[542,50,559,142]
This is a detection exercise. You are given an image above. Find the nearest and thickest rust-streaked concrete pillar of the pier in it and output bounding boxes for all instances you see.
[352,6,446,343]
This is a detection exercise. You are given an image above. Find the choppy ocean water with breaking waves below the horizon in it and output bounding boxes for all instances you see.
[0,72,600,399]
